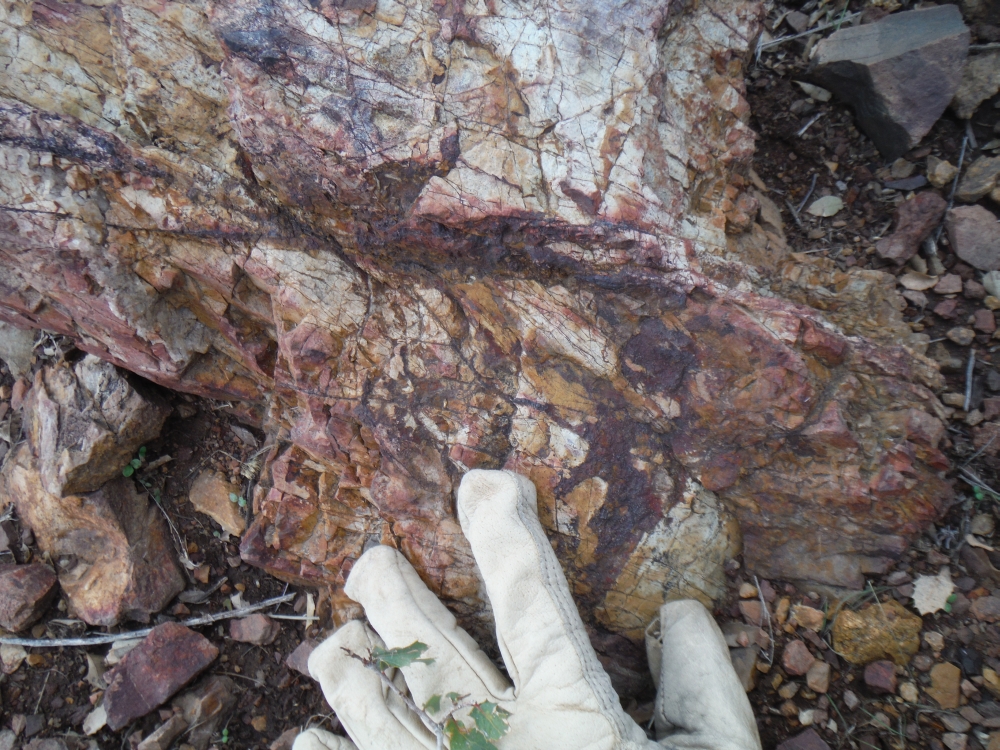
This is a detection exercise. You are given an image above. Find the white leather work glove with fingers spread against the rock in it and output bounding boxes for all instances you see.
[293,470,760,750]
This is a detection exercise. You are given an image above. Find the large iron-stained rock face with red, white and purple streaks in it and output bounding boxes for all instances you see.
[0,0,950,652]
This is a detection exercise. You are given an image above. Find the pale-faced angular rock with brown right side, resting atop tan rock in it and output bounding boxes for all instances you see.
[25,355,170,497]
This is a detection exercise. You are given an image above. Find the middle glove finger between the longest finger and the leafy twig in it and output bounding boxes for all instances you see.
[344,547,513,706]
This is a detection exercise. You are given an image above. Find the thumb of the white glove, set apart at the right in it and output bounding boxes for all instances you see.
[655,599,760,750]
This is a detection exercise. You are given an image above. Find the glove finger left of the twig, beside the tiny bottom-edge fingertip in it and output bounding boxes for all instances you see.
[309,620,437,750]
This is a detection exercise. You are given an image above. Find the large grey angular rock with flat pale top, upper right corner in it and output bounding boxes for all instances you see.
[811,5,970,159]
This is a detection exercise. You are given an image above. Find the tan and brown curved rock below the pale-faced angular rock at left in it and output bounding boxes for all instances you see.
[0,444,184,625]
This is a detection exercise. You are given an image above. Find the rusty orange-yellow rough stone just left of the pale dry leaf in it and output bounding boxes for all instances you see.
[833,599,924,665]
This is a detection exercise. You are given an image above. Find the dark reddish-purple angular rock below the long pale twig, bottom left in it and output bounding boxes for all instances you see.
[104,623,219,731]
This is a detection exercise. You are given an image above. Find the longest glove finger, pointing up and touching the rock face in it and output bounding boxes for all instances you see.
[458,469,646,743]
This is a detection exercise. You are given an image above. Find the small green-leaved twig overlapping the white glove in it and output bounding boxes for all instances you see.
[344,641,510,750]
